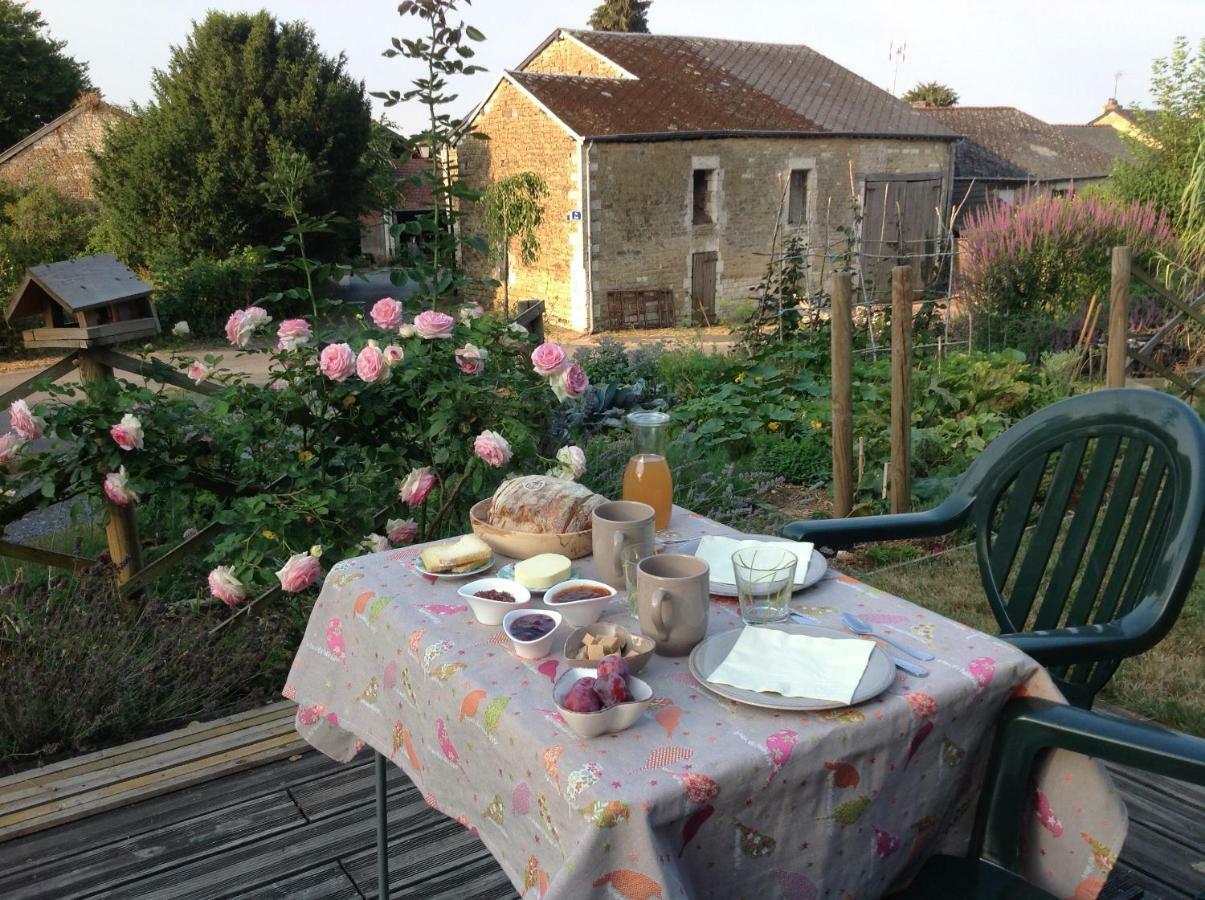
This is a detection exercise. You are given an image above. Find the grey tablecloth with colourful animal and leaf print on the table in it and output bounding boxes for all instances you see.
[284,508,1125,900]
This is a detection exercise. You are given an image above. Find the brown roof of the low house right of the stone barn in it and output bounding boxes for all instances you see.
[922,106,1113,181]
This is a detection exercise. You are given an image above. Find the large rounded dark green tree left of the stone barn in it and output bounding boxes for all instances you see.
[94,11,372,261]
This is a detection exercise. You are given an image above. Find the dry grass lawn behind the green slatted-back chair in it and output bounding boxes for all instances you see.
[850,547,1205,736]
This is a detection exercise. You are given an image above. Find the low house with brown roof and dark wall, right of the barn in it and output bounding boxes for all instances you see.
[923,106,1116,224]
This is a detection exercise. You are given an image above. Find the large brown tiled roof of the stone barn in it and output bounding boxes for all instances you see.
[509,31,954,140]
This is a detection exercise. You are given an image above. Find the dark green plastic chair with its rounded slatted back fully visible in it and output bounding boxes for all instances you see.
[782,389,1205,707]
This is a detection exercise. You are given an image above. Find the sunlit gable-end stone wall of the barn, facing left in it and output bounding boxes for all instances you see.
[457,80,587,329]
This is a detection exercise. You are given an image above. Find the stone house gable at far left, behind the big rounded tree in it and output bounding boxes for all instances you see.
[0,92,129,200]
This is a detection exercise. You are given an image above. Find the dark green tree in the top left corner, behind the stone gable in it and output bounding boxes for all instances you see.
[0,0,92,149]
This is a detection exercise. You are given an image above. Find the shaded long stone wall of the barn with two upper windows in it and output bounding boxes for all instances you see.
[587,137,953,322]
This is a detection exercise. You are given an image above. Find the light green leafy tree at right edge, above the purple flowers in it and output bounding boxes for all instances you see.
[1110,37,1205,228]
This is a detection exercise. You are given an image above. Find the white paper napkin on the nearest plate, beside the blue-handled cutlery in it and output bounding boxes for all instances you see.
[707,628,875,704]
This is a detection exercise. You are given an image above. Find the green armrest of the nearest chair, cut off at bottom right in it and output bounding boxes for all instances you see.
[971,698,1205,871]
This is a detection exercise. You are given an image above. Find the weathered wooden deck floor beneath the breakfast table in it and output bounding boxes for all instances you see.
[0,704,1205,900]
